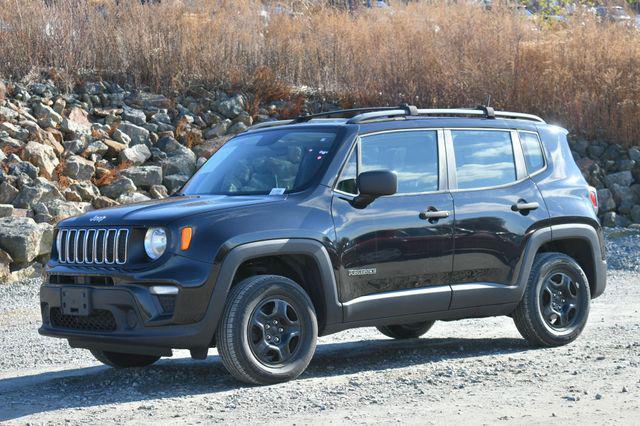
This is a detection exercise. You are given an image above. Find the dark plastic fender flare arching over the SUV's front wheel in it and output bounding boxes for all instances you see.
[205,238,342,340]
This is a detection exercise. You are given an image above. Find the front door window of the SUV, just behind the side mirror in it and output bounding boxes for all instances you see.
[359,131,438,194]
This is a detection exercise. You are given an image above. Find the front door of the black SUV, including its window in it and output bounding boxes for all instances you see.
[332,130,453,321]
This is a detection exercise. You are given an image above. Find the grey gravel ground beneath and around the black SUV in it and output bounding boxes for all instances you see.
[0,230,640,424]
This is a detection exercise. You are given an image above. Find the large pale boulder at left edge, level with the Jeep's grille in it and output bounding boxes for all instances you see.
[0,217,53,263]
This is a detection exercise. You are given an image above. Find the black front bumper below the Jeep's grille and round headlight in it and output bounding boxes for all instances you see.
[38,256,222,355]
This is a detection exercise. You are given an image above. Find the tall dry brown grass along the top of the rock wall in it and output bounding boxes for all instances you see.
[0,0,640,144]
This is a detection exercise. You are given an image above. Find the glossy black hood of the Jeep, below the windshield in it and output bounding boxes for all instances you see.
[58,195,284,227]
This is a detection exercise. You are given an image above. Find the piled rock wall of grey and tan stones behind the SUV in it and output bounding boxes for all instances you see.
[0,80,640,282]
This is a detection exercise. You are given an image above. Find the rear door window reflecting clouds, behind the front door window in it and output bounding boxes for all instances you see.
[451,130,516,189]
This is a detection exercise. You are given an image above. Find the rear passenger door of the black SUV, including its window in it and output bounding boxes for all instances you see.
[445,129,548,309]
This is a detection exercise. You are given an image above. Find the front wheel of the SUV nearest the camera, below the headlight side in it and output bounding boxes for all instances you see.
[216,275,318,385]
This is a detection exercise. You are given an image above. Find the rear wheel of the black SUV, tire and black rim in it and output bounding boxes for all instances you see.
[513,253,591,346]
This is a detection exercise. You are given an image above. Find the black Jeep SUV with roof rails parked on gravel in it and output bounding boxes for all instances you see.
[39,105,606,384]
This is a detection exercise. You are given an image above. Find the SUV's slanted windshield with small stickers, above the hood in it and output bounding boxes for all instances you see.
[182,129,336,195]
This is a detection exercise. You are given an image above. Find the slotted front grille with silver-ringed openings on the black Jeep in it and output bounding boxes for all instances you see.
[56,228,129,265]
